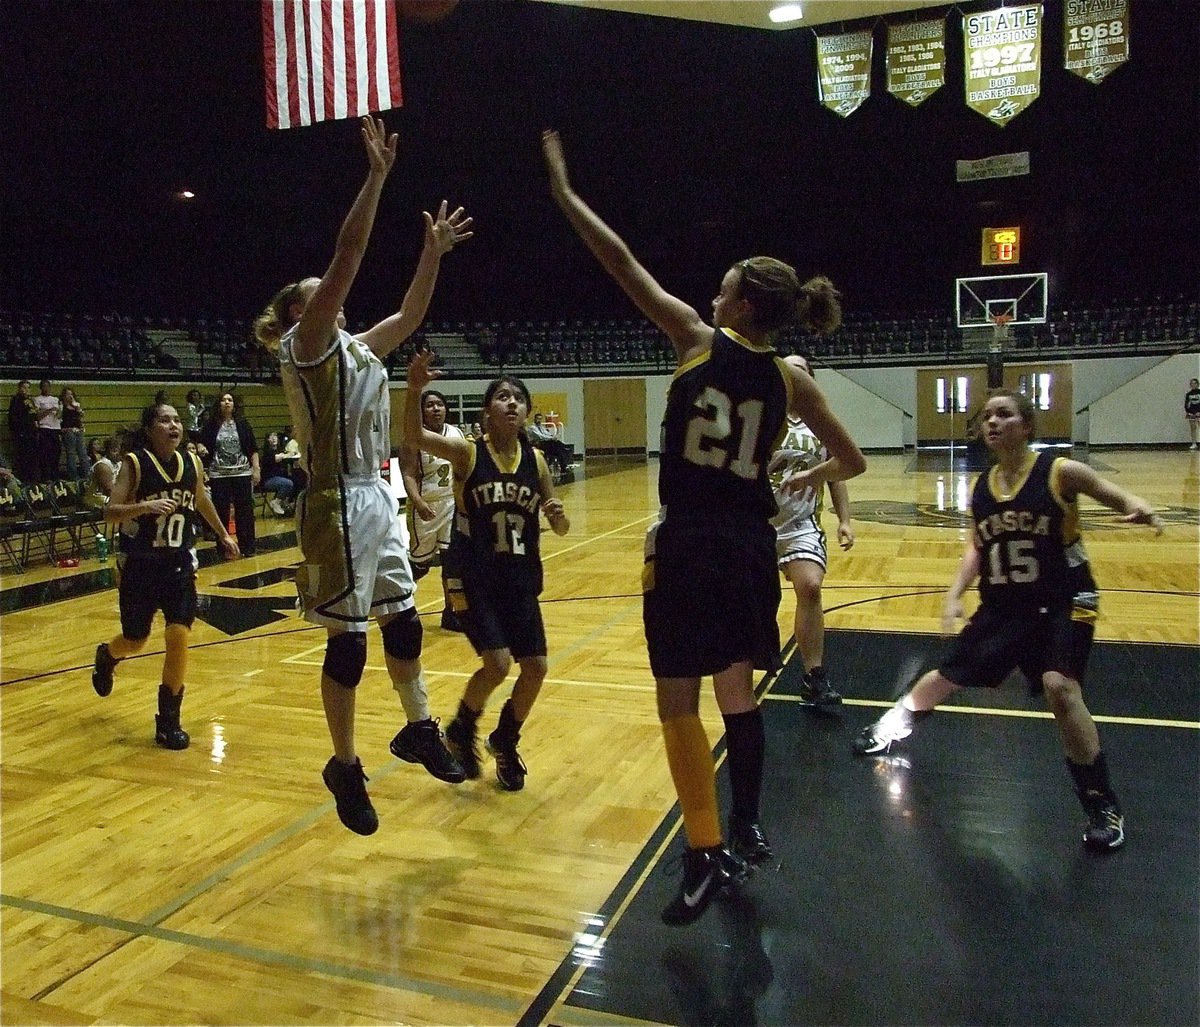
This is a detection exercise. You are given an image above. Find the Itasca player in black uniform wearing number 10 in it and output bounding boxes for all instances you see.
[91,403,240,749]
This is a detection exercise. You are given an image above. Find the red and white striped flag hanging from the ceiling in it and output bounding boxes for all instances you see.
[263,0,401,128]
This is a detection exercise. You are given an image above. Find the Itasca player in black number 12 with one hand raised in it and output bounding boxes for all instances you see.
[404,352,571,792]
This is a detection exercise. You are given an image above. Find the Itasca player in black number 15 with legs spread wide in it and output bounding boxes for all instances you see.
[854,390,1163,852]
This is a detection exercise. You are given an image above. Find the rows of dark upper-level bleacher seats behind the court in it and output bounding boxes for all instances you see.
[0,296,1200,382]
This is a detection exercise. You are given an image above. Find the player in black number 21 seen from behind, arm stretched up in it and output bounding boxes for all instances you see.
[542,132,865,925]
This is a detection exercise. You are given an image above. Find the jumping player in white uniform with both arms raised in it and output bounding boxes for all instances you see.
[254,118,473,835]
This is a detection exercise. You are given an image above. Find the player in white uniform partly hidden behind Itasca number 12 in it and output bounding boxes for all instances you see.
[400,389,464,631]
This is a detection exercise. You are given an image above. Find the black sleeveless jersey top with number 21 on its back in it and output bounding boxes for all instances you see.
[659,329,790,517]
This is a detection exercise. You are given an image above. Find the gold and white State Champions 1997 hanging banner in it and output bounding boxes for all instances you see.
[962,4,1042,125]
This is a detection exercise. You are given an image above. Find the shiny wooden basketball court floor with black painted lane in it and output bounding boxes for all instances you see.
[0,451,1200,1025]
